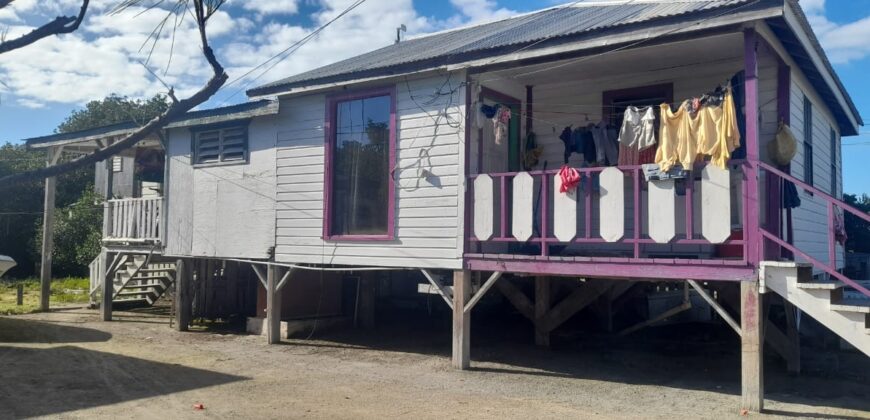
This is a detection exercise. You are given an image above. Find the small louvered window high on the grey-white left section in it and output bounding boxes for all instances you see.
[192,124,248,165]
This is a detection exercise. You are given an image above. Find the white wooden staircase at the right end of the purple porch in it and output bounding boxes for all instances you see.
[760,261,870,356]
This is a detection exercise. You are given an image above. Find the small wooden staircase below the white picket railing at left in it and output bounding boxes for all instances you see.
[91,254,175,306]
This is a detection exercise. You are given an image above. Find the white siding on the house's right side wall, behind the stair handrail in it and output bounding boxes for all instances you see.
[790,79,843,273]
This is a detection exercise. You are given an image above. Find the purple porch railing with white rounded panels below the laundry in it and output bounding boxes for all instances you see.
[466,161,748,266]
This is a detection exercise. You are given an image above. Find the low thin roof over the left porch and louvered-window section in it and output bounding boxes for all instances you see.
[24,99,276,146]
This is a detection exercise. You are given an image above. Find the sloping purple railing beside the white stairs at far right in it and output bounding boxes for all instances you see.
[757,162,870,297]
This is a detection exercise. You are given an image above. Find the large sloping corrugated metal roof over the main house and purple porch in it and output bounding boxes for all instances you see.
[248,0,758,96]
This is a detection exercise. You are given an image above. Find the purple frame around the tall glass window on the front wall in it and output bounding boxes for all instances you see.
[321,86,397,241]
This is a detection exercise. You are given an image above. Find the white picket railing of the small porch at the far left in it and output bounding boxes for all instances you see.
[103,197,164,243]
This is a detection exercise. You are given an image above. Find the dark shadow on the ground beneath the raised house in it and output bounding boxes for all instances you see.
[283,304,870,418]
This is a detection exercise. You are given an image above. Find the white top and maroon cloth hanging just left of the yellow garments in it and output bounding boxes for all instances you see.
[617,106,656,165]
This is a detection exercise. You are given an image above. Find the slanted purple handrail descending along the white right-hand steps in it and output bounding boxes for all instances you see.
[755,161,870,297]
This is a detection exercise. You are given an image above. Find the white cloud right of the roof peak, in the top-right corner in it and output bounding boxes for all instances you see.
[800,0,870,64]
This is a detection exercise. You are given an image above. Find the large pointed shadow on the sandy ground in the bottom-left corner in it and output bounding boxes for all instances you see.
[0,346,248,418]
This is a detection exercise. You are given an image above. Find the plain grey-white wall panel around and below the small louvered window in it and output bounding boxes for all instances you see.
[165,117,275,258]
